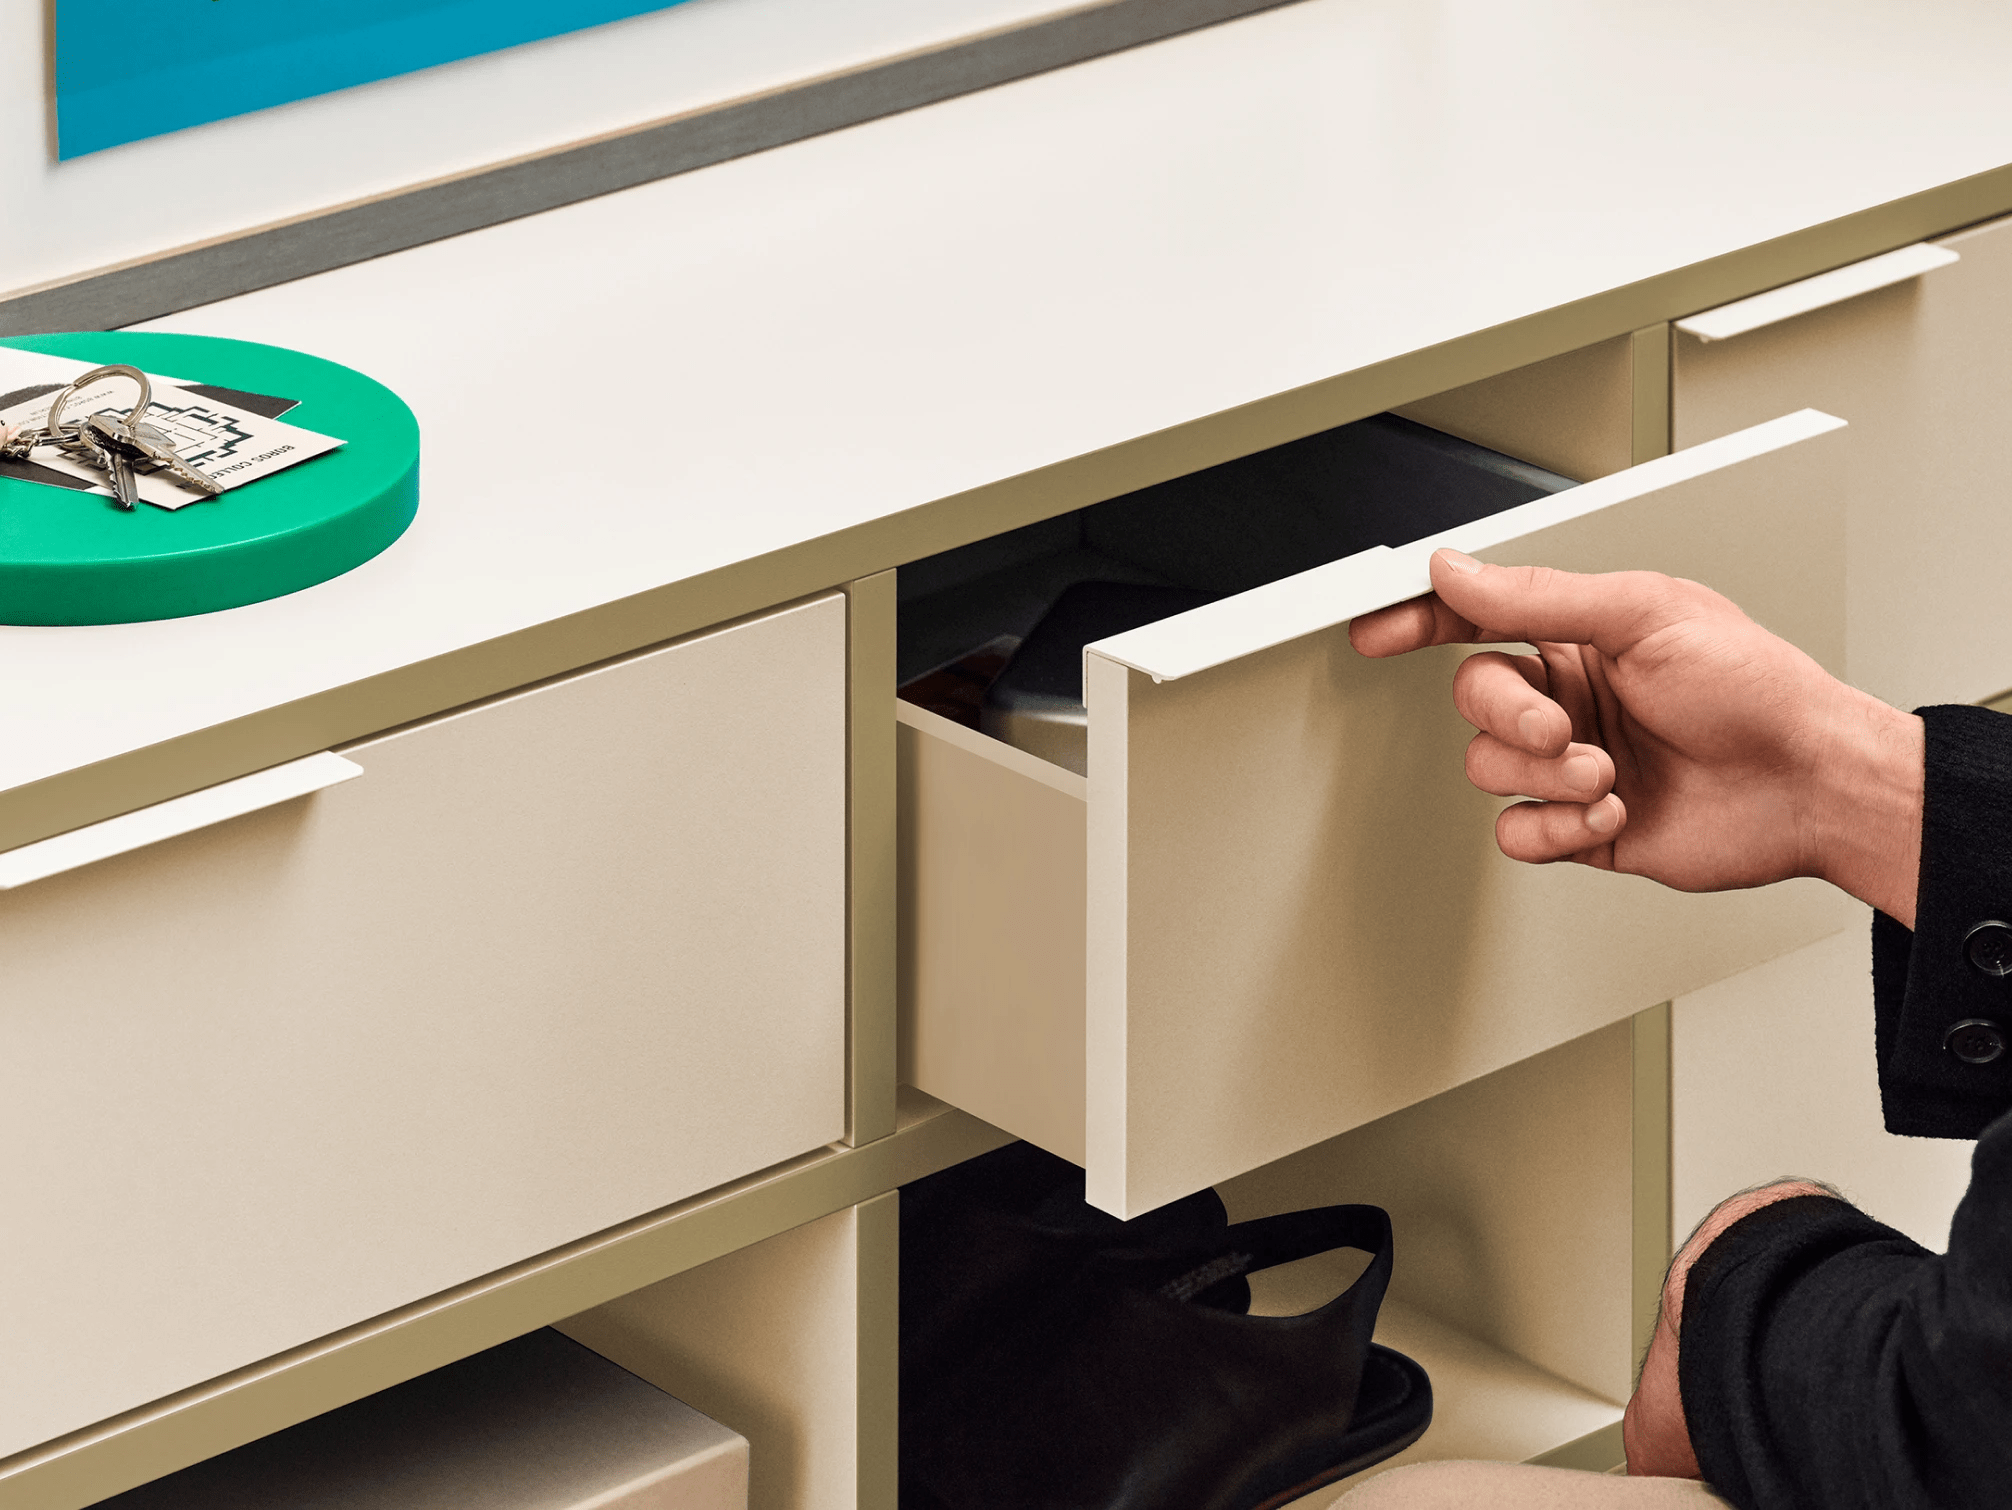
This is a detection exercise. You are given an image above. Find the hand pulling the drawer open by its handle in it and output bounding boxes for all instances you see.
[1348,550,1923,926]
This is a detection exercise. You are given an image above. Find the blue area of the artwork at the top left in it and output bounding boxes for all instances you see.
[56,0,692,157]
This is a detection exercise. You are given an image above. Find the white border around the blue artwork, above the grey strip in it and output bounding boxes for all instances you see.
[0,0,1072,296]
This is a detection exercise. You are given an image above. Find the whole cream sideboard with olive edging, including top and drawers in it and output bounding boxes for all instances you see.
[0,0,2012,1510]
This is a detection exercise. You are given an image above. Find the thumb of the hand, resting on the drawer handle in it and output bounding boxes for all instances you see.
[1433,550,1686,656]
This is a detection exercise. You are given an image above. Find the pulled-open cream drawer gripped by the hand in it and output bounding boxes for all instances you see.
[899,411,1849,1216]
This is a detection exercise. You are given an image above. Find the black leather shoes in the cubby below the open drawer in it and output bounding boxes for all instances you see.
[901,1151,1433,1510]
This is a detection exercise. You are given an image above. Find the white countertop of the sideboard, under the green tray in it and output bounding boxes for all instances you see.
[0,0,2012,844]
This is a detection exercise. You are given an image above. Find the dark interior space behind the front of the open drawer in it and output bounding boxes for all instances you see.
[897,415,1575,752]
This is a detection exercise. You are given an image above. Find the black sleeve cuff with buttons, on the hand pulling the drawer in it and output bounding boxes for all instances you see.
[1873,707,2012,1138]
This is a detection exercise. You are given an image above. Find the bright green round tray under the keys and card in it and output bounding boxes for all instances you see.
[0,330,418,624]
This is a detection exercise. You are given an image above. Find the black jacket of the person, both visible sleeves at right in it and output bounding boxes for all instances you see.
[1678,707,2012,1510]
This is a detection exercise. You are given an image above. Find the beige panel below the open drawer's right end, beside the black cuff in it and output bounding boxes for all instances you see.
[1670,934,1972,1252]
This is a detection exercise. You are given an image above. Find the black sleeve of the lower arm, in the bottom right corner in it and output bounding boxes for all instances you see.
[1676,1117,2012,1510]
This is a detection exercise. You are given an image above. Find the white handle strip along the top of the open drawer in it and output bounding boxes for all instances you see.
[1082,409,1845,681]
